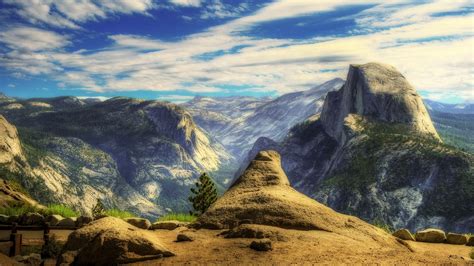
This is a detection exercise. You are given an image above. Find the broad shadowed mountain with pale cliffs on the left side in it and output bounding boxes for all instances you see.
[0,97,231,216]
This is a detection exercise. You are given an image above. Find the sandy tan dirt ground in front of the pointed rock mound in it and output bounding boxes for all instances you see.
[134,228,474,265]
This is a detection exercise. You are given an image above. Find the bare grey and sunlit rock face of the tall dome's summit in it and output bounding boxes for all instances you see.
[321,63,440,140]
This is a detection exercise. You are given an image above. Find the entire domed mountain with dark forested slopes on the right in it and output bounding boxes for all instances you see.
[238,63,474,231]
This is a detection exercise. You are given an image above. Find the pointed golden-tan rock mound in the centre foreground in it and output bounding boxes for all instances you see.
[196,151,406,246]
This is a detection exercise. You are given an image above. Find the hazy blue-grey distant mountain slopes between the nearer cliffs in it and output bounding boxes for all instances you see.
[182,79,344,161]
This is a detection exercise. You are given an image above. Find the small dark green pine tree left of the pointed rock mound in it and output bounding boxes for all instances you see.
[189,173,217,216]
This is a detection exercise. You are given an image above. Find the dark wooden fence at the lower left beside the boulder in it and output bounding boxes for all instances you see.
[0,223,77,257]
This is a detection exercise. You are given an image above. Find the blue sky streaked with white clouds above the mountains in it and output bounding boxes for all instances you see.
[0,0,474,103]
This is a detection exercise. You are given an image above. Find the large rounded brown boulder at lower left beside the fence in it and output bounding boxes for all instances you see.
[58,217,174,265]
